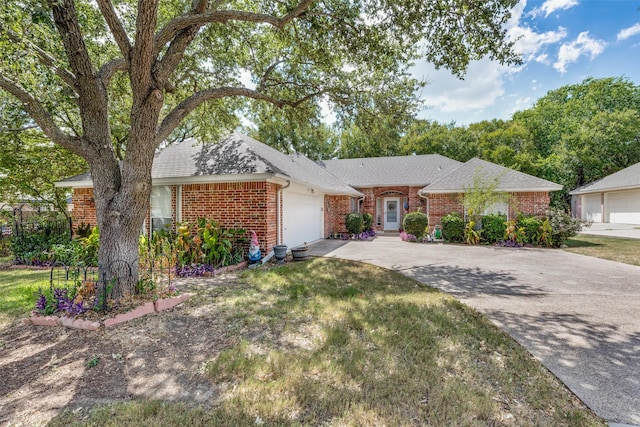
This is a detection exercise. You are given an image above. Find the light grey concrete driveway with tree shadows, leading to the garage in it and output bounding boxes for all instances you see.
[312,236,640,425]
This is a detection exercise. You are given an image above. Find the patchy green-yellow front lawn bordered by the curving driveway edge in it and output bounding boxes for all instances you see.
[51,259,604,426]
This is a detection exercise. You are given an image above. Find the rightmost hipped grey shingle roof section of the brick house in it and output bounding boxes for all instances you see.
[422,158,562,193]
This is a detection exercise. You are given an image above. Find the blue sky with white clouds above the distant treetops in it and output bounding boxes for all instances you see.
[413,0,640,125]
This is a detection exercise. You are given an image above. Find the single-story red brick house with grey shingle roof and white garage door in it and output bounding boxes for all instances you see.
[56,132,562,251]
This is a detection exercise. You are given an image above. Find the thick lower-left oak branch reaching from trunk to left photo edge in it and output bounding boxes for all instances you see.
[0,74,83,156]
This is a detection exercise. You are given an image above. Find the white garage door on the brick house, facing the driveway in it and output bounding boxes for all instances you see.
[282,190,324,248]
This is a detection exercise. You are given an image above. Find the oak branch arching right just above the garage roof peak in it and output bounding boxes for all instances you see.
[156,87,326,146]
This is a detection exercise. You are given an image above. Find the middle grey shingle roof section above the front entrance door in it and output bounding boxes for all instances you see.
[321,154,462,188]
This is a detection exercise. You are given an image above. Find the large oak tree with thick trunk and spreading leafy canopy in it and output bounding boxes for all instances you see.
[0,0,518,297]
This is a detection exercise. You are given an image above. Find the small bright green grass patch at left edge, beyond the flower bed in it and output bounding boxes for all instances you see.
[0,268,50,329]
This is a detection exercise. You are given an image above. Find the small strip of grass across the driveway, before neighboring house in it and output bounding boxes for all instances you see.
[565,234,640,265]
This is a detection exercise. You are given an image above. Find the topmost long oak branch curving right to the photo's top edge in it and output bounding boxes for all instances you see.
[155,0,314,55]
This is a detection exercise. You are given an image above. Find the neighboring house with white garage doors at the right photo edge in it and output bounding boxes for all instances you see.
[569,163,640,224]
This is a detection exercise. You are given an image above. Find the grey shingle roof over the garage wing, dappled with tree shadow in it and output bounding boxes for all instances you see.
[58,132,362,196]
